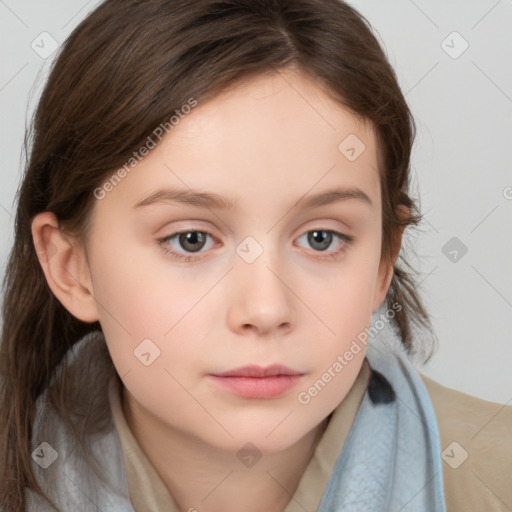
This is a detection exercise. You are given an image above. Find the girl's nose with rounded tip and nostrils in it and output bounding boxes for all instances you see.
[228,251,296,336]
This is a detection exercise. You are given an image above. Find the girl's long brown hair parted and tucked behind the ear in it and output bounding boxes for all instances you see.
[0,0,431,512]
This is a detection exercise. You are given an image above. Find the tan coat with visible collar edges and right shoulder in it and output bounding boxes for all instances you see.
[109,359,512,512]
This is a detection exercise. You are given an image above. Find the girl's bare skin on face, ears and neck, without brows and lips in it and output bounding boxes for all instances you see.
[32,70,399,512]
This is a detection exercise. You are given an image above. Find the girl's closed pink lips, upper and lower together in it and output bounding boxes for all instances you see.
[209,365,304,398]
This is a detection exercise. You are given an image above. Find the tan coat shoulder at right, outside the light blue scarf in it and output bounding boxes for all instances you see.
[419,372,512,512]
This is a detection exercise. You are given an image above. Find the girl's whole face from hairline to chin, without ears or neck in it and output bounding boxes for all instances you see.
[57,71,389,452]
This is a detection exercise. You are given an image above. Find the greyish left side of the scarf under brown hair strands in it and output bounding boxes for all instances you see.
[27,337,133,512]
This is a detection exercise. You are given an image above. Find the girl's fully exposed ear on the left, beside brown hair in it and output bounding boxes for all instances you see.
[32,212,99,322]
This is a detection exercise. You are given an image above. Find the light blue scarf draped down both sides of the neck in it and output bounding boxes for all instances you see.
[27,345,446,512]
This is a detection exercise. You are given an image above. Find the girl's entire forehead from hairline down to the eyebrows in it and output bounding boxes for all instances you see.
[93,70,380,218]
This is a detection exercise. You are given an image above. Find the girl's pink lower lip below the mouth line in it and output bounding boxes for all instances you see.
[210,375,302,398]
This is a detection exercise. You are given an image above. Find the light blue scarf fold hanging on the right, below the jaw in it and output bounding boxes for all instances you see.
[318,345,446,512]
